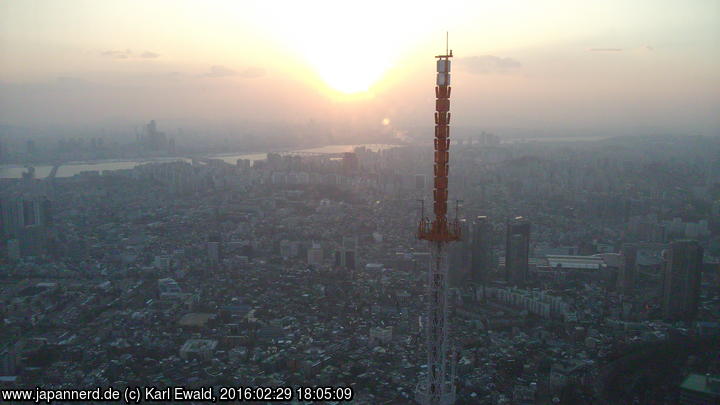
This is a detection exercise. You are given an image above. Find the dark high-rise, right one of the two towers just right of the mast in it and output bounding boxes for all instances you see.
[505,217,530,285]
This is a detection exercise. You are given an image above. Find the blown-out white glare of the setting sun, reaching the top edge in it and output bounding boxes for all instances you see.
[248,0,417,97]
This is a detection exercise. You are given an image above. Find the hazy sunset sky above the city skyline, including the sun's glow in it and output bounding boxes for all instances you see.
[0,0,720,135]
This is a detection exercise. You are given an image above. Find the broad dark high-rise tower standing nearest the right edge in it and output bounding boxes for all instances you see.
[662,240,703,321]
